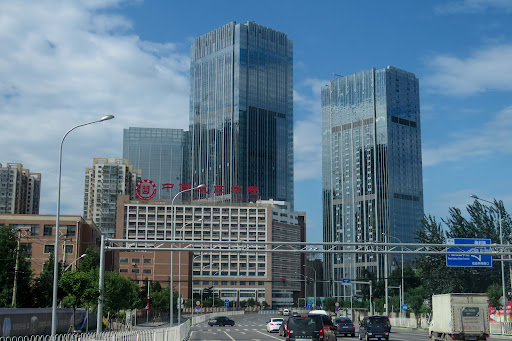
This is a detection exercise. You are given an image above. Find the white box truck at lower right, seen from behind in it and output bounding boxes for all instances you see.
[429,294,489,341]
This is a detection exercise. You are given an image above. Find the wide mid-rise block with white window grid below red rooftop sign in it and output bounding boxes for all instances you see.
[117,196,305,307]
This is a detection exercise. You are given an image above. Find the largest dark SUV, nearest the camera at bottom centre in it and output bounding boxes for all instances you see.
[286,314,336,341]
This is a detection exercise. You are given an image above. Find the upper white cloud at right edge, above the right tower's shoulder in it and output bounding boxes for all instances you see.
[423,45,512,96]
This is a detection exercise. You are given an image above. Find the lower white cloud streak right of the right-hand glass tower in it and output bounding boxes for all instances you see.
[422,106,512,166]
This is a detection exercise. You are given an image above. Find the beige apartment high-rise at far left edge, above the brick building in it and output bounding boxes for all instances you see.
[0,163,41,214]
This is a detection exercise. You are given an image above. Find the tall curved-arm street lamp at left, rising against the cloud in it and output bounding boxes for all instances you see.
[51,115,114,341]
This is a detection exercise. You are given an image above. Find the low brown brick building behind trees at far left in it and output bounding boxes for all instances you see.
[0,214,102,277]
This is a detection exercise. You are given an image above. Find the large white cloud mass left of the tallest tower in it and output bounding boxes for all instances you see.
[0,0,189,214]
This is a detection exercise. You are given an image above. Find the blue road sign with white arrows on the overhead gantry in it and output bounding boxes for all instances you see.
[446,238,492,268]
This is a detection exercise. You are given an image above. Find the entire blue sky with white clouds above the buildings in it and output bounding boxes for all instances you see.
[0,0,512,242]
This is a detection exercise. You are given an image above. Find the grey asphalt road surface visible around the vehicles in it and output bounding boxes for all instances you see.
[189,314,512,341]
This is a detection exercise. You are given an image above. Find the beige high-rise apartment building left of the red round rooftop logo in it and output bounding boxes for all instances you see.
[84,158,141,238]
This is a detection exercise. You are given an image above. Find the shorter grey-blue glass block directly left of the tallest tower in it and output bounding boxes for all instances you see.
[123,127,189,200]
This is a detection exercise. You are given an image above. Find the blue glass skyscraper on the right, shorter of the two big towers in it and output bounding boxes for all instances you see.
[322,66,423,296]
